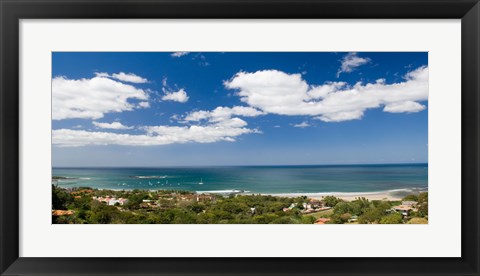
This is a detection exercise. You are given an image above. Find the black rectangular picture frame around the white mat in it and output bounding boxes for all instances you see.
[0,0,480,275]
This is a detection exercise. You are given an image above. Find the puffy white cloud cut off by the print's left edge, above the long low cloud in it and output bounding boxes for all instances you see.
[52,75,149,120]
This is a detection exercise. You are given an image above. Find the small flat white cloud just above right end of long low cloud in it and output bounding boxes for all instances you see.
[184,106,264,122]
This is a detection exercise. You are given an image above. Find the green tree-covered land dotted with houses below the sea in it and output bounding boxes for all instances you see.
[52,185,428,224]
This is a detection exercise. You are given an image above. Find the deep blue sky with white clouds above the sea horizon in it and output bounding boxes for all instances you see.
[52,52,428,167]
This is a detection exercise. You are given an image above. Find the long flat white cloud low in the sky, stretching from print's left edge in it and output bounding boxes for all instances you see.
[52,118,259,147]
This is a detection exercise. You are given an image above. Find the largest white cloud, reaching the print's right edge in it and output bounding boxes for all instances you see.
[224,66,428,122]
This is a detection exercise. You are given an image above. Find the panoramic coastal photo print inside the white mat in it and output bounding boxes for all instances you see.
[51,52,429,224]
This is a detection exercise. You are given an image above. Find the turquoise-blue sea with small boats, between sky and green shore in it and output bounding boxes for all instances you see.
[53,164,428,194]
